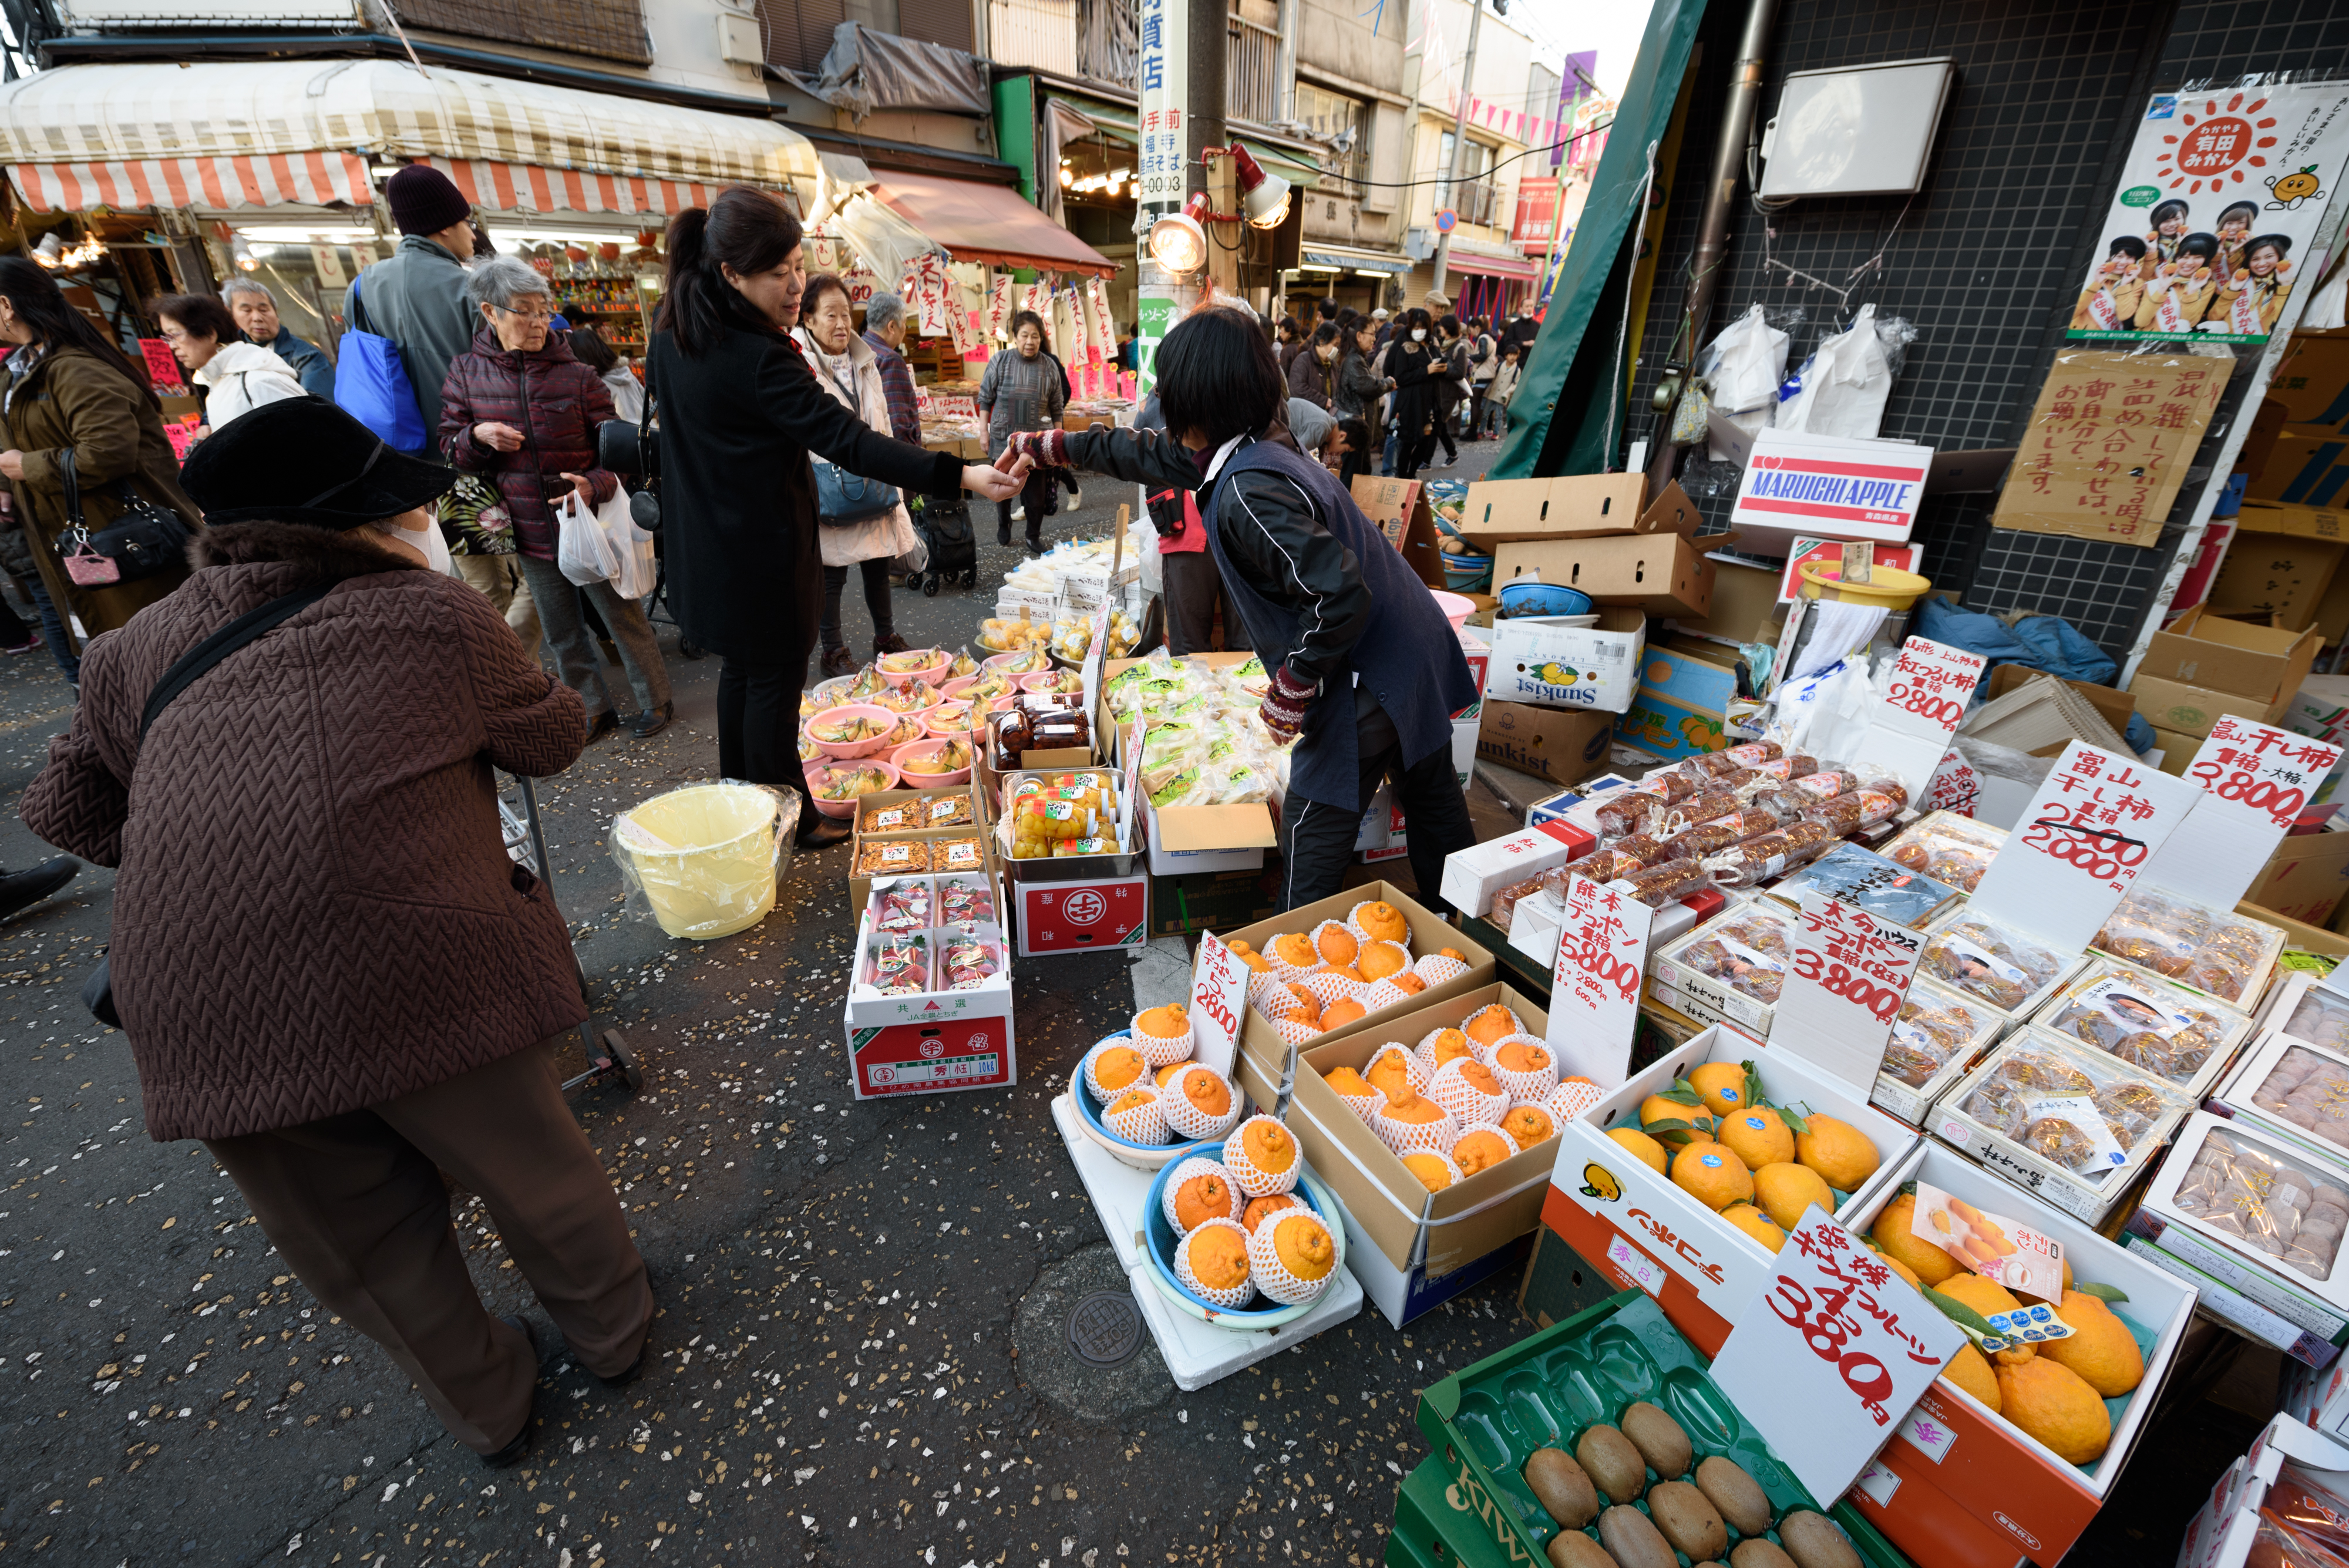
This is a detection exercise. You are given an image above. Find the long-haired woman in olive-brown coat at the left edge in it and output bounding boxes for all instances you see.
[0,256,200,676]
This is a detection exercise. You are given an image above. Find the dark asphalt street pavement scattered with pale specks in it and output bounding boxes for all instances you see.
[0,443,1579,1568]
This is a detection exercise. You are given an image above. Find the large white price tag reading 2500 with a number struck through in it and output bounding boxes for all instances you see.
[1968,742,2199,953]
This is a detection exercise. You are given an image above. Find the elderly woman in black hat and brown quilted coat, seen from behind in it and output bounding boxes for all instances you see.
[21,396,653,1465]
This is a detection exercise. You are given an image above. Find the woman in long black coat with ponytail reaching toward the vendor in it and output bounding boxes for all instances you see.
[646,186,1019,845]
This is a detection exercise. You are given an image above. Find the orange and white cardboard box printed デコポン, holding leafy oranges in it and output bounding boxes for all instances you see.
[1541,1024,1917,1357]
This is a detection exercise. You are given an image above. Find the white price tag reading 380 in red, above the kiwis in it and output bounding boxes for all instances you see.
[1712,1209,1966,1498]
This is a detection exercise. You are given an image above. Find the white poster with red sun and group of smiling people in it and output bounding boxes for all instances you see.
[2069,82,2349,343]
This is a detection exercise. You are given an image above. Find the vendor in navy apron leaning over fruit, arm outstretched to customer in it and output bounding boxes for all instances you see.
[1003,305,1475,913]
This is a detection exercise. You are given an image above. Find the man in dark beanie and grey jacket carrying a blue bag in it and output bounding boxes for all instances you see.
[343,164,479,462]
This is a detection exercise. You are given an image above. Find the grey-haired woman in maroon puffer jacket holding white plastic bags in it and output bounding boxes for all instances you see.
[439,256,674,742]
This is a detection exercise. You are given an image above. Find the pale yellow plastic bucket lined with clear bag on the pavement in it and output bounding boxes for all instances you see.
[613,784,775,941]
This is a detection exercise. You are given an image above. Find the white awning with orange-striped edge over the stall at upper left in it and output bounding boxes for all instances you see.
[0,59,820,211]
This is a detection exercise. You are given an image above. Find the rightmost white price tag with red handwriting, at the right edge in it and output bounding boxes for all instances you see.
[2145,714,2342,909]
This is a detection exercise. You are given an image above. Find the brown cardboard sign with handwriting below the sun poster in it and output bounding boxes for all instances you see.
[1990,350,2234,549]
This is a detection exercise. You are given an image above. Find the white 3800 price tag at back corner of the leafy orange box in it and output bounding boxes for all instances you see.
[1769,890,1924,1099]
